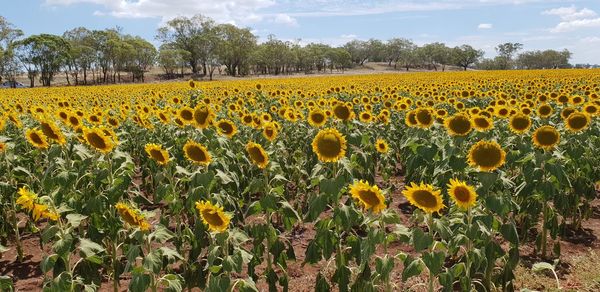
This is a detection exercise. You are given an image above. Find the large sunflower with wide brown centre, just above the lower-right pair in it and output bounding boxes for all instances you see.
[468,141,506,171]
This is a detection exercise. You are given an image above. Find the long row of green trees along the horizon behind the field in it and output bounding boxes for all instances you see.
[0,15,571,87]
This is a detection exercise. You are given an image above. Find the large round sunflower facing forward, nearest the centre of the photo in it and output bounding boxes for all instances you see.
[312,128,346,162]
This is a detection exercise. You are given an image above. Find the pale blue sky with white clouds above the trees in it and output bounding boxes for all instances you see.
[0,0,600,64]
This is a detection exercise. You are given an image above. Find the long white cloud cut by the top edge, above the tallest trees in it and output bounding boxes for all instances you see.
[45,0,275,23]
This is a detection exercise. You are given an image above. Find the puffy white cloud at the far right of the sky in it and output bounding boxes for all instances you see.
[542,6,600,33]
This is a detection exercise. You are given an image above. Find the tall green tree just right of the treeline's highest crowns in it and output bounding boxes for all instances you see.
[216,24,256,76]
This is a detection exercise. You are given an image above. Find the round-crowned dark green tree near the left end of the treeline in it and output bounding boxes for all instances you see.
[18,34,70,86]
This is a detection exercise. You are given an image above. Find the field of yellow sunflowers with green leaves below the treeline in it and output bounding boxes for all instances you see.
[0,70,600,291]
